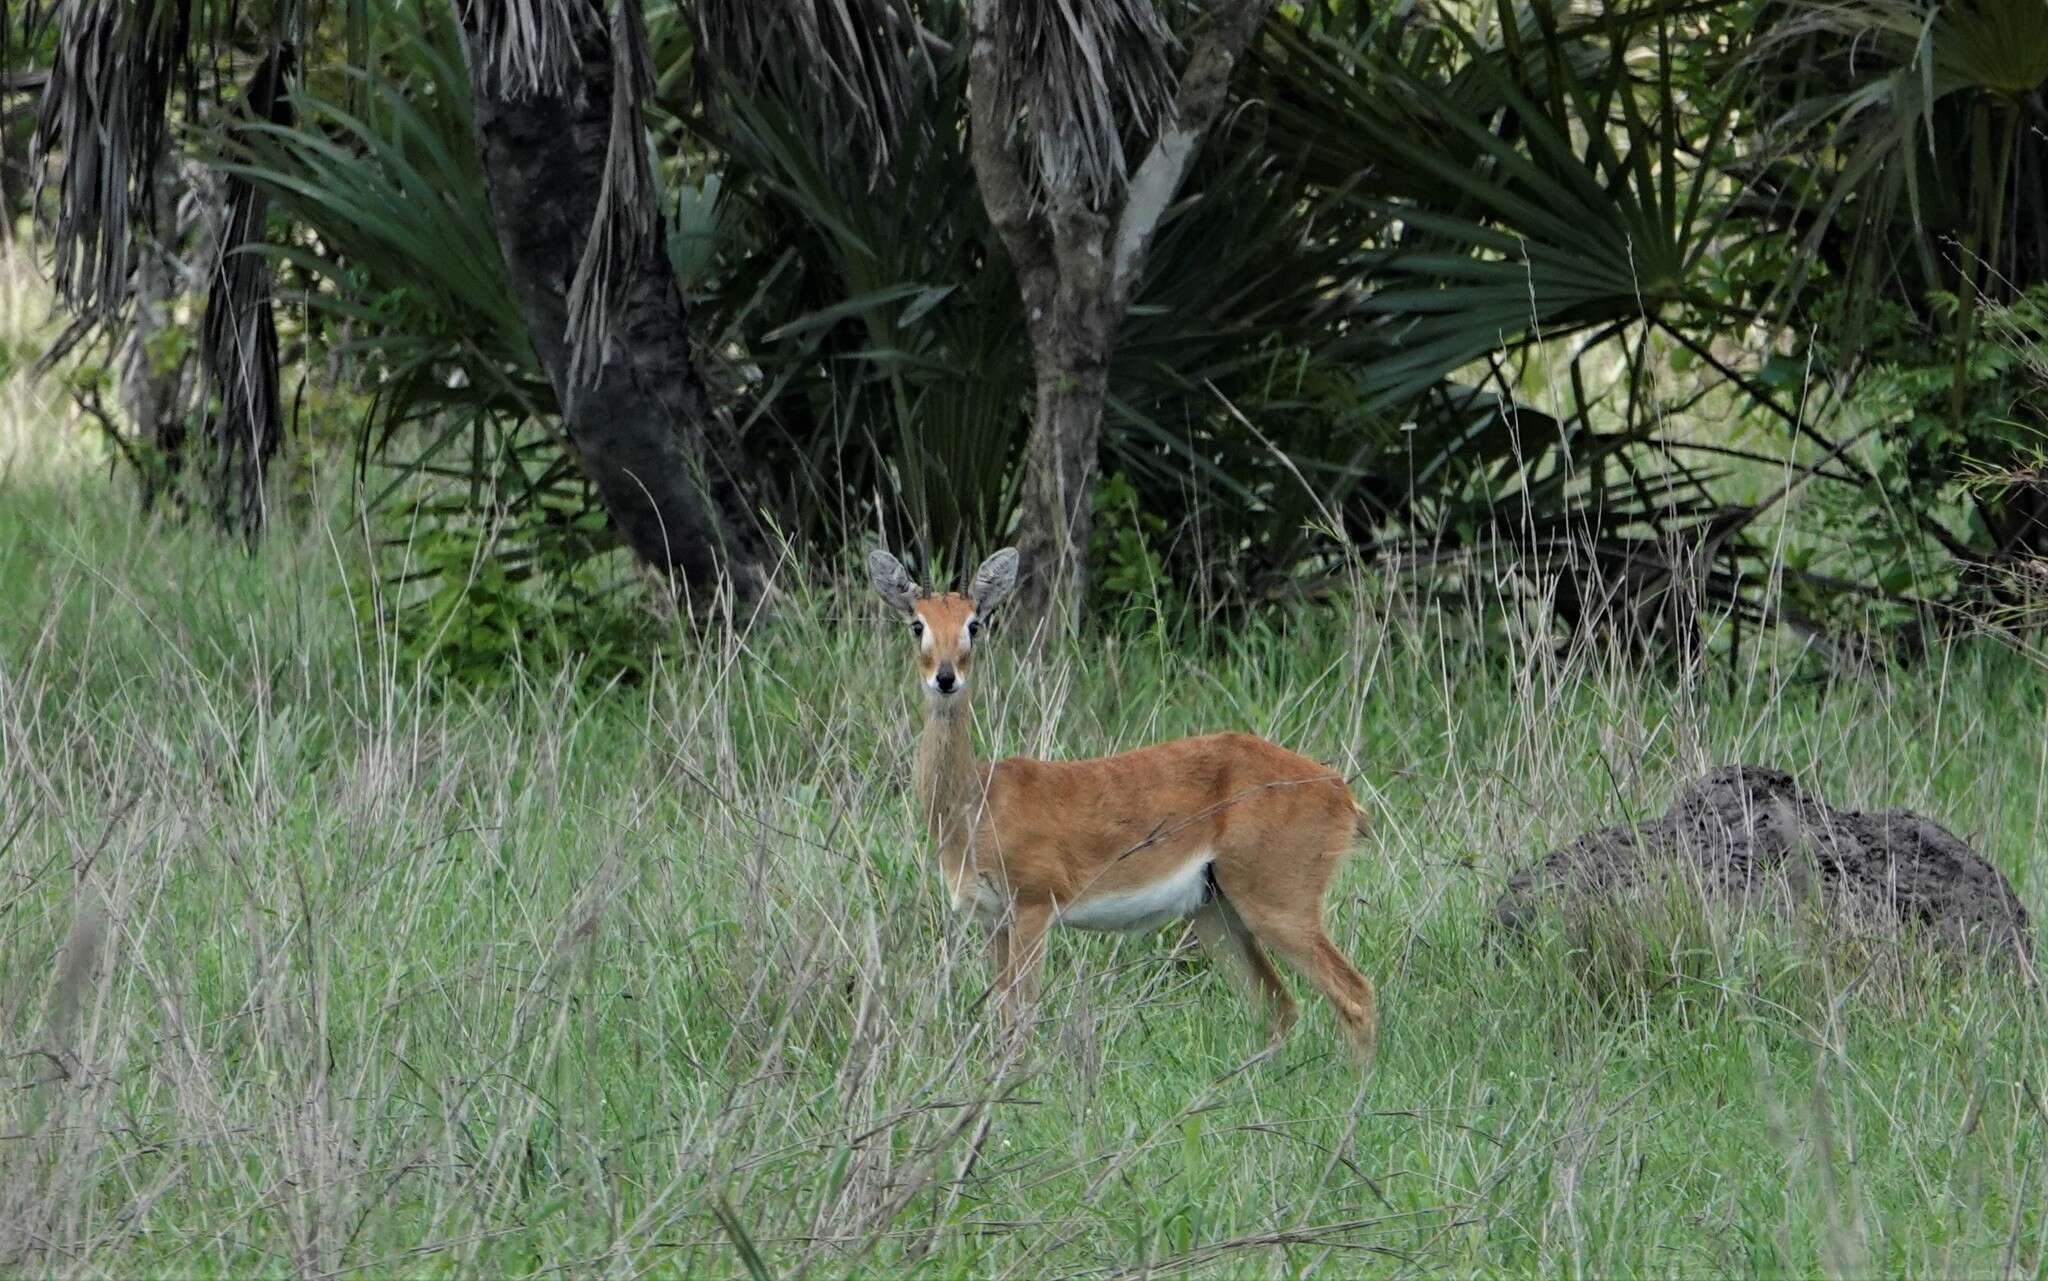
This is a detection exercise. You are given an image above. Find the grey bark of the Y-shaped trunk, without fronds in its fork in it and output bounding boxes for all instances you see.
[969,0,1272,631]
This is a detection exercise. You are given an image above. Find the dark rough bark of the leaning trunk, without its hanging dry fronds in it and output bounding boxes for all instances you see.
[463,6,764,603]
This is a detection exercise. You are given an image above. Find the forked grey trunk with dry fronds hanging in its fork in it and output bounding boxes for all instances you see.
[969,0,1272,625]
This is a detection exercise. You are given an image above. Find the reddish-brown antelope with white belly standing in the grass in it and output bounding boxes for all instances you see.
[868,549,1374,1062]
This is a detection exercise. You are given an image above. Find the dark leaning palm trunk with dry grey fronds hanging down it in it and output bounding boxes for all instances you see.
[459,0,762,596]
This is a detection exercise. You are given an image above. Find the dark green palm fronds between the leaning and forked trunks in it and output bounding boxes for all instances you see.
[698,6,1030,564]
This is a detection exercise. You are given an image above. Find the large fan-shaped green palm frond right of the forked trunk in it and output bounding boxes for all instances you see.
[1274,0,1735,406]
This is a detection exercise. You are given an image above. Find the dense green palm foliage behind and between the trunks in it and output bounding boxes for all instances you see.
[12,0,2048,676]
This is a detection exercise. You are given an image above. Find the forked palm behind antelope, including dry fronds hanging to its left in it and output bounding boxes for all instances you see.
[698,0,1272,627]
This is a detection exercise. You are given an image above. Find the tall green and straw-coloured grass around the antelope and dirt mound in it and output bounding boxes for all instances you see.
[0,469,2048,1277]
